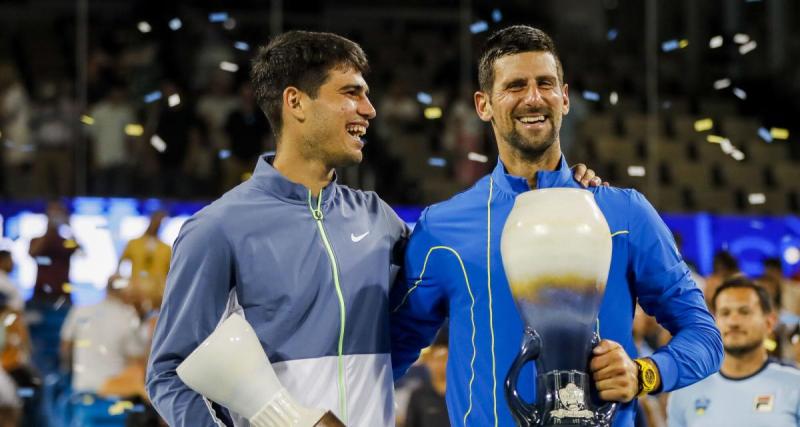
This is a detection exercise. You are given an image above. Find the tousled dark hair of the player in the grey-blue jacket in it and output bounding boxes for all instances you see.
[250,31,369,136]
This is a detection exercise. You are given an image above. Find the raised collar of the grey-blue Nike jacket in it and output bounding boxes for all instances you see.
[250,153,337,205]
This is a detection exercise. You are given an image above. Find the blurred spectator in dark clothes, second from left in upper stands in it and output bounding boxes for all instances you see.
[31,82,79,197]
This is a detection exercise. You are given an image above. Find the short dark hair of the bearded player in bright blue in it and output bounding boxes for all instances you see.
[478,25,564,92]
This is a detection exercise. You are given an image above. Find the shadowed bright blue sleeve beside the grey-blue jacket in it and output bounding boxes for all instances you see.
[389,210,447,380]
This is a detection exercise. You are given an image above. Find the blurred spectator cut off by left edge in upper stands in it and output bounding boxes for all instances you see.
[0,64,33,197]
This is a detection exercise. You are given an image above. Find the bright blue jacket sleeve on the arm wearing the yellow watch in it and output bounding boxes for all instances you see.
[629,191,722,391]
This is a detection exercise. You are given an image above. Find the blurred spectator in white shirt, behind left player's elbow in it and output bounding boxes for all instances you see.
[60,275,145,393]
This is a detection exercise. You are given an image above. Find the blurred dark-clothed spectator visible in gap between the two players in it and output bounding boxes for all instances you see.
[405,326,450,427]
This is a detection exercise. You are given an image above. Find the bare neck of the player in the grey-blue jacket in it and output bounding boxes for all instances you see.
[272,141,333,195]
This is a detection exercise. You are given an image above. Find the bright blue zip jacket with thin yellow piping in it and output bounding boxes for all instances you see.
[390,157,722,427]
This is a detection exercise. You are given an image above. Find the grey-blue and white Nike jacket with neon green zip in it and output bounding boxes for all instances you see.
[147,157,407,427]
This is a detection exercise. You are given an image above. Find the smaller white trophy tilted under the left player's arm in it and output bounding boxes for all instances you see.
[177,314,344,427]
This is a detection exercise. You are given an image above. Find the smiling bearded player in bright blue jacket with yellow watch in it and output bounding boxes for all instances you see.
[390,26,722,427]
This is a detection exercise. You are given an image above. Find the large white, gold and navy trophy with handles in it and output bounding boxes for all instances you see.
[501,188,616,427]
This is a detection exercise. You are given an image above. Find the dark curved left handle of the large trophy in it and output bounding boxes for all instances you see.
[505,327,542,427]
